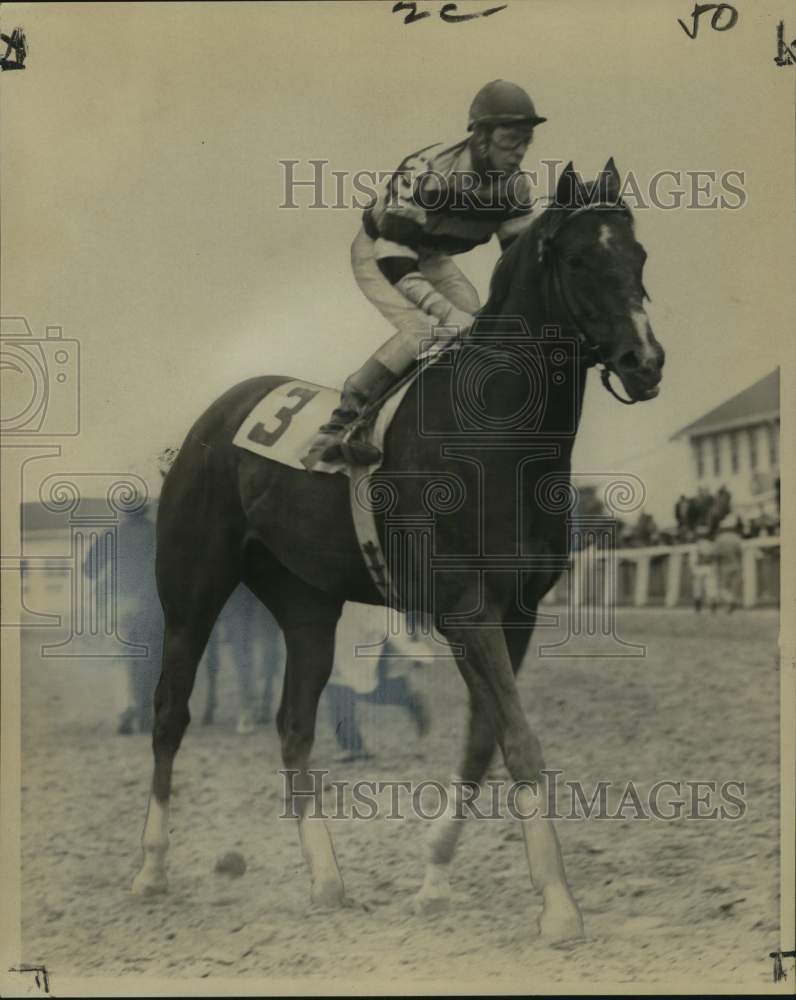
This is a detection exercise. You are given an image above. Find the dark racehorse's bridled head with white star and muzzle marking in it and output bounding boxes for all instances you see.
[538,159,664,402]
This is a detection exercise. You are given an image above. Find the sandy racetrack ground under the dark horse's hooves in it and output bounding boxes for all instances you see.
[17,610,787,995]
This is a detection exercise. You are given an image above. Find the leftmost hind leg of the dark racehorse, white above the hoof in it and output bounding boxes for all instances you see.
[132,524,240,895]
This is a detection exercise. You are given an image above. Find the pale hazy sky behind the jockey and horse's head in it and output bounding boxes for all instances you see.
[0,0,796,524]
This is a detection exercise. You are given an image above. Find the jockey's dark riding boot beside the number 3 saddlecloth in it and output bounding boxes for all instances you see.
[302,358,399,469]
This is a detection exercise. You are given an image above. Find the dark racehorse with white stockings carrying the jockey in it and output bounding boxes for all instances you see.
[132,159,664,943]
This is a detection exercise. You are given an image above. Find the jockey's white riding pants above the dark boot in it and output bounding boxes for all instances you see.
[351,229,479,375]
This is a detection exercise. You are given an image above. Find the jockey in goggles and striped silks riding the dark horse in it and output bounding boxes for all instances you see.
[305,80,547,468]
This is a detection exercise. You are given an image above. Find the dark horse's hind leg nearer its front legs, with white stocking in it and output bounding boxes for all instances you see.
[244,557,344,906]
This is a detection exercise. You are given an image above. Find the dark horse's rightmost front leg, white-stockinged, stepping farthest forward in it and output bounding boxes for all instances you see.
[432,612,583,942]
